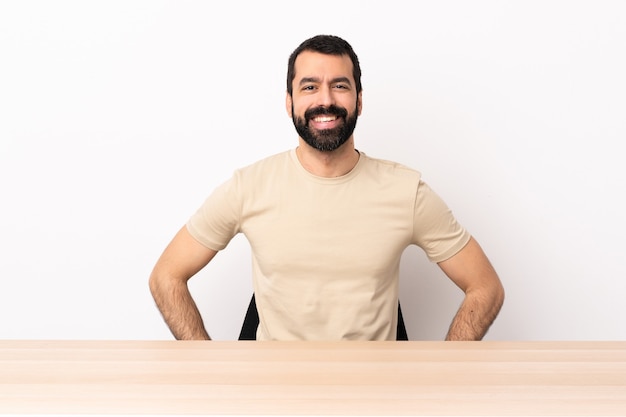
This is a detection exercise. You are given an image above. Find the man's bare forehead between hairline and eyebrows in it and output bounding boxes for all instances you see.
[294,51,354,84]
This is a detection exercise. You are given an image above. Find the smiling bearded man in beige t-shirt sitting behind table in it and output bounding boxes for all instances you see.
[150,35,504,340]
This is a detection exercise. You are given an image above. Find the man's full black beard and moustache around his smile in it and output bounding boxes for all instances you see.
[291,104,358,152]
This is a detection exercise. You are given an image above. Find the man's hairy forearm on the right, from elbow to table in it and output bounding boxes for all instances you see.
[446,287,504,340]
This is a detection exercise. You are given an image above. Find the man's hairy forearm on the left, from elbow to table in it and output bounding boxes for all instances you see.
[150,277,211,340]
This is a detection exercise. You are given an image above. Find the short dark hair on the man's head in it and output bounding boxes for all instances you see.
[287,35,362,95]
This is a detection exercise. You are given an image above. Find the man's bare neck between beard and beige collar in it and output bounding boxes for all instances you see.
[296,138,359,178]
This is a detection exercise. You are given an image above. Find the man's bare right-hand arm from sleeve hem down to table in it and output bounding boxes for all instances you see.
[439,238,504,340]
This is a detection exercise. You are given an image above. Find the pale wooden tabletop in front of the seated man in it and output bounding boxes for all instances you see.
[0,340,626,416]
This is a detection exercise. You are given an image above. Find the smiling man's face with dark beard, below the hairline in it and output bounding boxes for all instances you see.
[287,51,361,152]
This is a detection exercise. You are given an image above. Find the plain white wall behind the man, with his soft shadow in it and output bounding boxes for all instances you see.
[0,0,626,340]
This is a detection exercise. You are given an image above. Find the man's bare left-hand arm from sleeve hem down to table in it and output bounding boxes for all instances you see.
[149,226,217,340]
